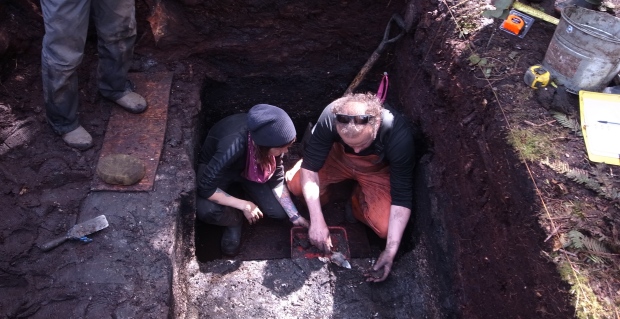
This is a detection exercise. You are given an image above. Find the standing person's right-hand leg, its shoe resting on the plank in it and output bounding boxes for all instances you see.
[92,0,146,113]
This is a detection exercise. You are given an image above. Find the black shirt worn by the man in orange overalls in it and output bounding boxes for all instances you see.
[301,104,415,209]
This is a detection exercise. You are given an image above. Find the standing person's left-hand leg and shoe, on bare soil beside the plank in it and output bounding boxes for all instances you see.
[41,0,92,149]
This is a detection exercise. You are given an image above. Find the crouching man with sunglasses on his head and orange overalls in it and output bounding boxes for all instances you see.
[286,93,414,282]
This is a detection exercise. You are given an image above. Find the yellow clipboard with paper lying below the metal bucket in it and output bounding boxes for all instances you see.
[579,91,620,165]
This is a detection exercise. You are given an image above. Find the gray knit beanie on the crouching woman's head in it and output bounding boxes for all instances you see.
[248,104,297,147]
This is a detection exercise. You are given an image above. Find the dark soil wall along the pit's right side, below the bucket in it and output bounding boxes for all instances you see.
[395,3,573,318]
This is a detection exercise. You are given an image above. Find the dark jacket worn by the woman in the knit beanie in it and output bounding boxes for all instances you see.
[196,113,284,198]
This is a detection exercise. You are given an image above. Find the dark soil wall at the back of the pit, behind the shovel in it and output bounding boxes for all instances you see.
[138,0,405,84]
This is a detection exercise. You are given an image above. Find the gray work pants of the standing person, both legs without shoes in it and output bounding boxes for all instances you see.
[41,0,136,134]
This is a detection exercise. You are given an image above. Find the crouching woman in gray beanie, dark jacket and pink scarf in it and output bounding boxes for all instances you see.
[196,104,308,255]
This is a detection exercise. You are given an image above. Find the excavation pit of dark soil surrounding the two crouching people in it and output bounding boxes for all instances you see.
[0,1,574,318]
